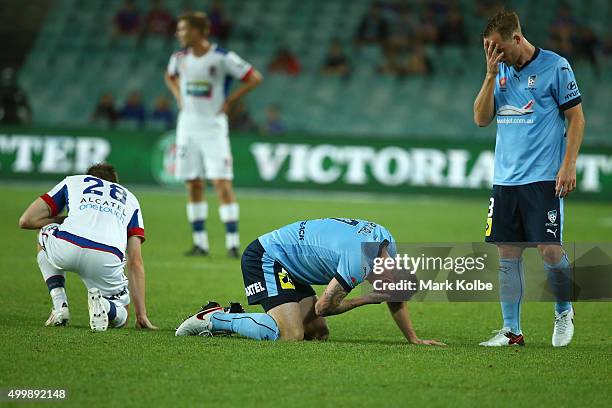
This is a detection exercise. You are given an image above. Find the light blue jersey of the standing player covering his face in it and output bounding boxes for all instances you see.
[493,48,582,185]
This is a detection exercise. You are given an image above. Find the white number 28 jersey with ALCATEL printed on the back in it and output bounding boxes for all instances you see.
[41,175,145,260]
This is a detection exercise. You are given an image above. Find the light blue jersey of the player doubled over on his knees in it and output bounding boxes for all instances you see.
[259,218,395,291]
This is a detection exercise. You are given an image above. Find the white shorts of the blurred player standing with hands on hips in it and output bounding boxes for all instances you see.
[176,116,234,180]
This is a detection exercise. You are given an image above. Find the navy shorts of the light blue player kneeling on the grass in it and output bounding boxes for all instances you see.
[242,239,315,312]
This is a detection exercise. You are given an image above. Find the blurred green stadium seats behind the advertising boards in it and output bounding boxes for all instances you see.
[20,0,612,139]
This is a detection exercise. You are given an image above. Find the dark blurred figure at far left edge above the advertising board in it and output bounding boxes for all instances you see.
[0,68,32,124]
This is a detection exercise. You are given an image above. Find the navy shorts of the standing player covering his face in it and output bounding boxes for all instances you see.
[485,181,563,246]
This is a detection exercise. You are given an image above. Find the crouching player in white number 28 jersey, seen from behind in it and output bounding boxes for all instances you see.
[19,164,157,332]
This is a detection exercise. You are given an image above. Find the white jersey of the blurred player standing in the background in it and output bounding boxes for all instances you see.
[168,44,253,121]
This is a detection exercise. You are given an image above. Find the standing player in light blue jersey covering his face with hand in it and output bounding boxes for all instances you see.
[474,11,585,347]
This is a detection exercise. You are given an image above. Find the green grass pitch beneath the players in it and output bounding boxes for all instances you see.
[0,185,612,407]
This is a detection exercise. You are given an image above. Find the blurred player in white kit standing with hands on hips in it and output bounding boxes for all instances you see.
[165,12,262,258]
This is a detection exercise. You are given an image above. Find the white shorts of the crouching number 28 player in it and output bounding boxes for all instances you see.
[38,224,130,306]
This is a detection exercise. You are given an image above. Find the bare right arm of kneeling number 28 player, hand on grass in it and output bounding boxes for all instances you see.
[127,236,157,329]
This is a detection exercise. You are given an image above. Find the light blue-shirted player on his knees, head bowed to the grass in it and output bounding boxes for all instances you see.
[176,218,443,345]
